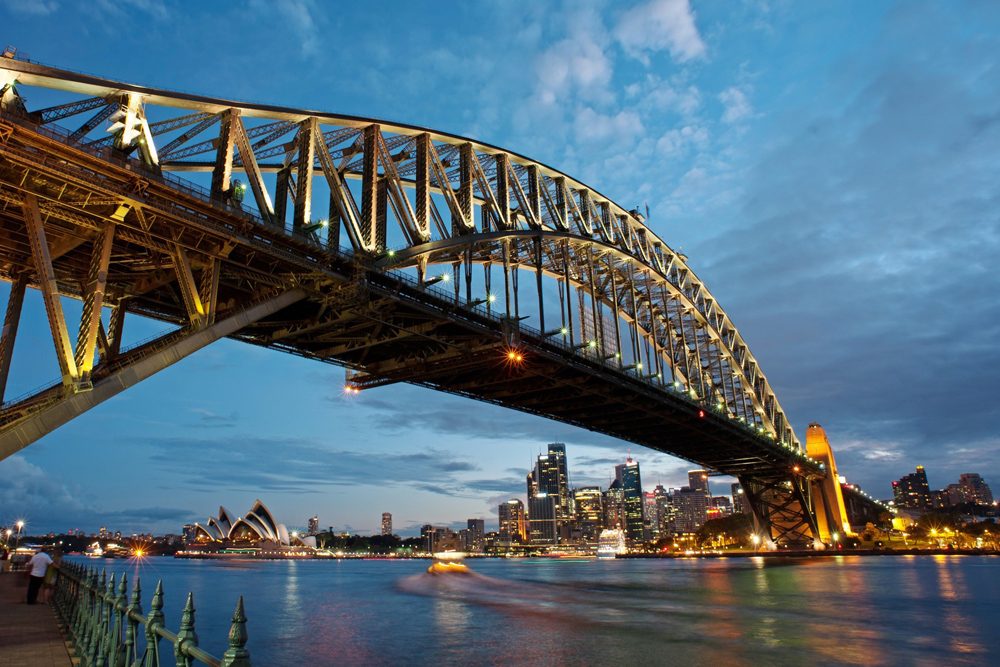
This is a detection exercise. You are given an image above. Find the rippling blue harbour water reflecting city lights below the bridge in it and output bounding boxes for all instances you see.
[72,556,1000,667]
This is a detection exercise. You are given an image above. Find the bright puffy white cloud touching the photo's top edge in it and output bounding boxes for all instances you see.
[614,0,705,62]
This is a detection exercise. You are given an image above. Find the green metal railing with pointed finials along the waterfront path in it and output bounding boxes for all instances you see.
[54,562,250,667]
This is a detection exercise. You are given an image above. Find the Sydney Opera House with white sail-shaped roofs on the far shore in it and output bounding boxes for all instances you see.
[183,500,316,556]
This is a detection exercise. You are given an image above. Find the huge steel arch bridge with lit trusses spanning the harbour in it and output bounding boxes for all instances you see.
[0,52,880,545]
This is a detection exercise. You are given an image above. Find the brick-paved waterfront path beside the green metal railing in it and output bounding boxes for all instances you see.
[0,572,71,667]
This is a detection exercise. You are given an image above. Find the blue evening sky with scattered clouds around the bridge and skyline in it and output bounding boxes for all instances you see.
[0,0,1000,531]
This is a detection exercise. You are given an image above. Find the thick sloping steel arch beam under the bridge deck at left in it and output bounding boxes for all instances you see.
[0,288,306,460]
